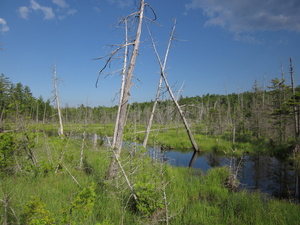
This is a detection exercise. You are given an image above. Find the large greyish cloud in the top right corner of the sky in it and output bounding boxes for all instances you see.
[186,0,300,34]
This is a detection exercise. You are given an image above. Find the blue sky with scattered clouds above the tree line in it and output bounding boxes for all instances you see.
[0,0,300,107]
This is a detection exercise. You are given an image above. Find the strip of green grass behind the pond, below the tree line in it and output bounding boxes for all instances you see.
[29,124,289,155]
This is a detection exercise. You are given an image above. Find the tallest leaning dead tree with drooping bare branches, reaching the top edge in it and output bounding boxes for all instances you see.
[96,0,147,179]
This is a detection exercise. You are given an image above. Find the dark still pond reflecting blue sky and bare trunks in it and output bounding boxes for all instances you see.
[148,148,299,199]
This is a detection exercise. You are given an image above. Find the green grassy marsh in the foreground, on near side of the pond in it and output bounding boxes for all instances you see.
[0,125,300,224]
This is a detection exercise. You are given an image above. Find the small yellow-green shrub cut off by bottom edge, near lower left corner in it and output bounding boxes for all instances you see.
[21,197,56,225]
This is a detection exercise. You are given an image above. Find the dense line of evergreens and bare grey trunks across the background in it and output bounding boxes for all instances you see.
[0,74,300,145]
